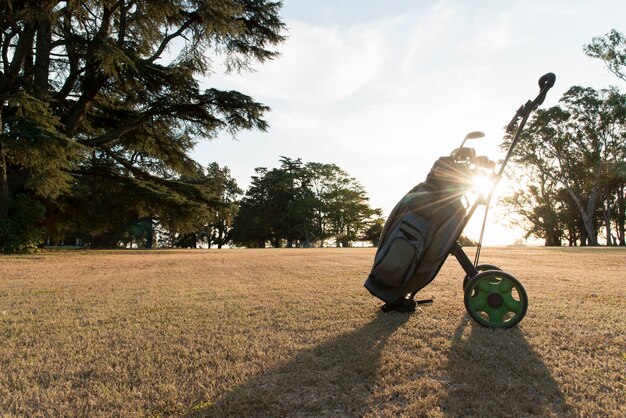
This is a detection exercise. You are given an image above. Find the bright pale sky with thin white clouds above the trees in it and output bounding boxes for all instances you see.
[192,0,626,245]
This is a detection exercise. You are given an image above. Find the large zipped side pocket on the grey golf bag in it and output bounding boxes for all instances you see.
[372,213,428,287]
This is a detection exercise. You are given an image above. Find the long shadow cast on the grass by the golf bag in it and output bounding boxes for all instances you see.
[195,313,410,417]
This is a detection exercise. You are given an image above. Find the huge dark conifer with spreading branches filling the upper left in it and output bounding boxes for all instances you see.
[0,0,284,251]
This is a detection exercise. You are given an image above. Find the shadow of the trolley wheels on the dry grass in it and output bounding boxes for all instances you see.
[442,317,574,417]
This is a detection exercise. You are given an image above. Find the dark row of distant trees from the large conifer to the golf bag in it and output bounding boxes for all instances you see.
[46,157,384,249]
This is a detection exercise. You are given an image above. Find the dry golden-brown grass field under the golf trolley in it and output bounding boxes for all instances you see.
[0,248,626,417]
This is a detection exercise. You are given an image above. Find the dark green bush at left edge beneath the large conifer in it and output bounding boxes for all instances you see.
[0,194,46,254]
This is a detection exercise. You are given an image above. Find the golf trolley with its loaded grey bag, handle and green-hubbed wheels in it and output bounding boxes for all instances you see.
[365,73,556,328]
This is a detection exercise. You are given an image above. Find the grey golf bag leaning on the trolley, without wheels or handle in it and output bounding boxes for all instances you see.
[365,153,473,310]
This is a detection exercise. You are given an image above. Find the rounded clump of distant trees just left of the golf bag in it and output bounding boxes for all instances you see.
[233,157,381,247]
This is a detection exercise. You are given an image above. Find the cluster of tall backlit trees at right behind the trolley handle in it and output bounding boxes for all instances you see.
[502,86,626,245]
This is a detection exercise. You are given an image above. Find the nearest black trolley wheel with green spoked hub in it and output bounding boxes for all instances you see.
[463,270,528,328]
